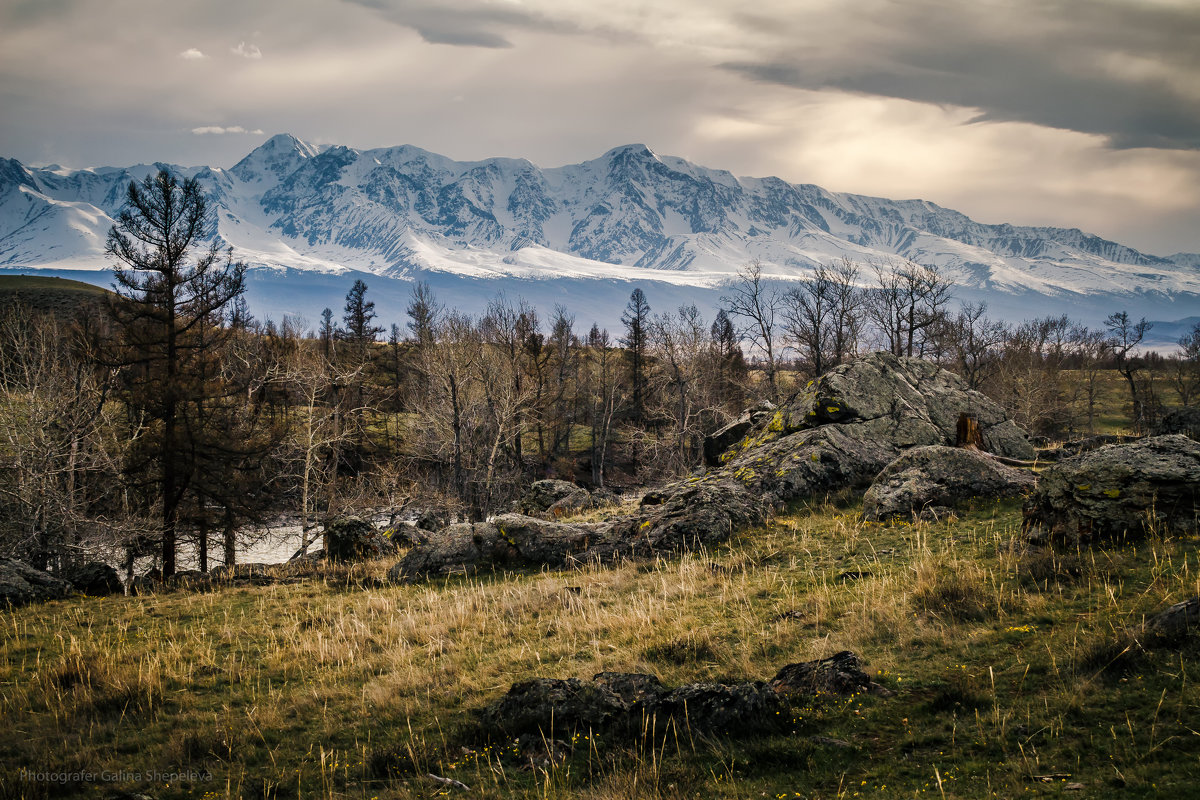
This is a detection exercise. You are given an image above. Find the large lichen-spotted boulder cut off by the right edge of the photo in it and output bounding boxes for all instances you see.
[1024,434,1200,545]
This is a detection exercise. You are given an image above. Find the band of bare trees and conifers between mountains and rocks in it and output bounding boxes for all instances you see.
[0,173,1200,575]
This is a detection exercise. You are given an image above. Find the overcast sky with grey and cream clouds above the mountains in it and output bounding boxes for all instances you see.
[7,0,1200,254]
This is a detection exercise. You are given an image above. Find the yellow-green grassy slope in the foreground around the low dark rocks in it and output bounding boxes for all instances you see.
[0,496,1200,798]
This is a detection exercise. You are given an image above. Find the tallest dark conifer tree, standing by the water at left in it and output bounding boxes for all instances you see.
[106,170,245,577]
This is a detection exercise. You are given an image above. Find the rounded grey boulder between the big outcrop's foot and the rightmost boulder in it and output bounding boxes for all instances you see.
[863,445,1037,522]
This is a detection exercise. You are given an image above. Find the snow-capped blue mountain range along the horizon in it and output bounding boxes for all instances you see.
[0,134,1200,335]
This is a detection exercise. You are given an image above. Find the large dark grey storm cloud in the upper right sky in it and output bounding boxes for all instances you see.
[722,0,1200,149]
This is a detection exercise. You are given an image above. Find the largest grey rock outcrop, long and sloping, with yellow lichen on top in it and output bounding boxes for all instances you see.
[390,353,1033,581]
